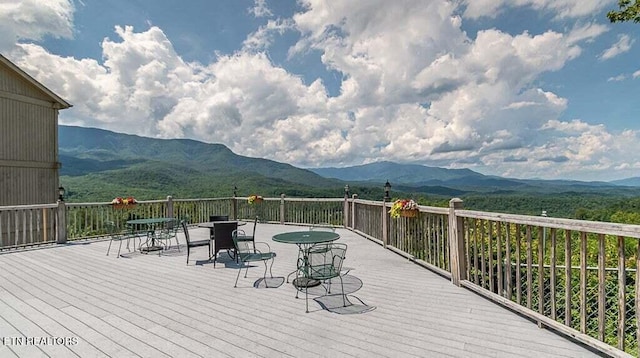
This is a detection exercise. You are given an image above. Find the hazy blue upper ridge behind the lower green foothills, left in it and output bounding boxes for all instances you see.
[59,126,336,187]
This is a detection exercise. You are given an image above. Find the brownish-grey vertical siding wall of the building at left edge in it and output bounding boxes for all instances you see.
[0,65,58,206]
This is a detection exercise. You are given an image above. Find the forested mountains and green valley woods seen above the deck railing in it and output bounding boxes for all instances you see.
[60,126,640,224]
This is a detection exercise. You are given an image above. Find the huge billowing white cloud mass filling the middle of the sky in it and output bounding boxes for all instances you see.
[5,0,640,178]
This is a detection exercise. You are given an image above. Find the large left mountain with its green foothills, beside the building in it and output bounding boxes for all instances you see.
[58,125,344,202]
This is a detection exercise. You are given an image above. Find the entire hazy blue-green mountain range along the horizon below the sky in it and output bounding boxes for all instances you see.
[59,125,640,201]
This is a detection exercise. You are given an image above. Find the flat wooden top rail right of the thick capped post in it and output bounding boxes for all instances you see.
[456,210,640,238]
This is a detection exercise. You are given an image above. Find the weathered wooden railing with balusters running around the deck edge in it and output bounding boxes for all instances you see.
[0,195,640,356]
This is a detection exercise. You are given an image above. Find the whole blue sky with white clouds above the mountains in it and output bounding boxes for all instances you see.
[0,0,640,181]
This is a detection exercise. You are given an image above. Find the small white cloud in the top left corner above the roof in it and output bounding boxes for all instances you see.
[0,0,75,52]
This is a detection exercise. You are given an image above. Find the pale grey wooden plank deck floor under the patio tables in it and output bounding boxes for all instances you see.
[0,224,597,358]
